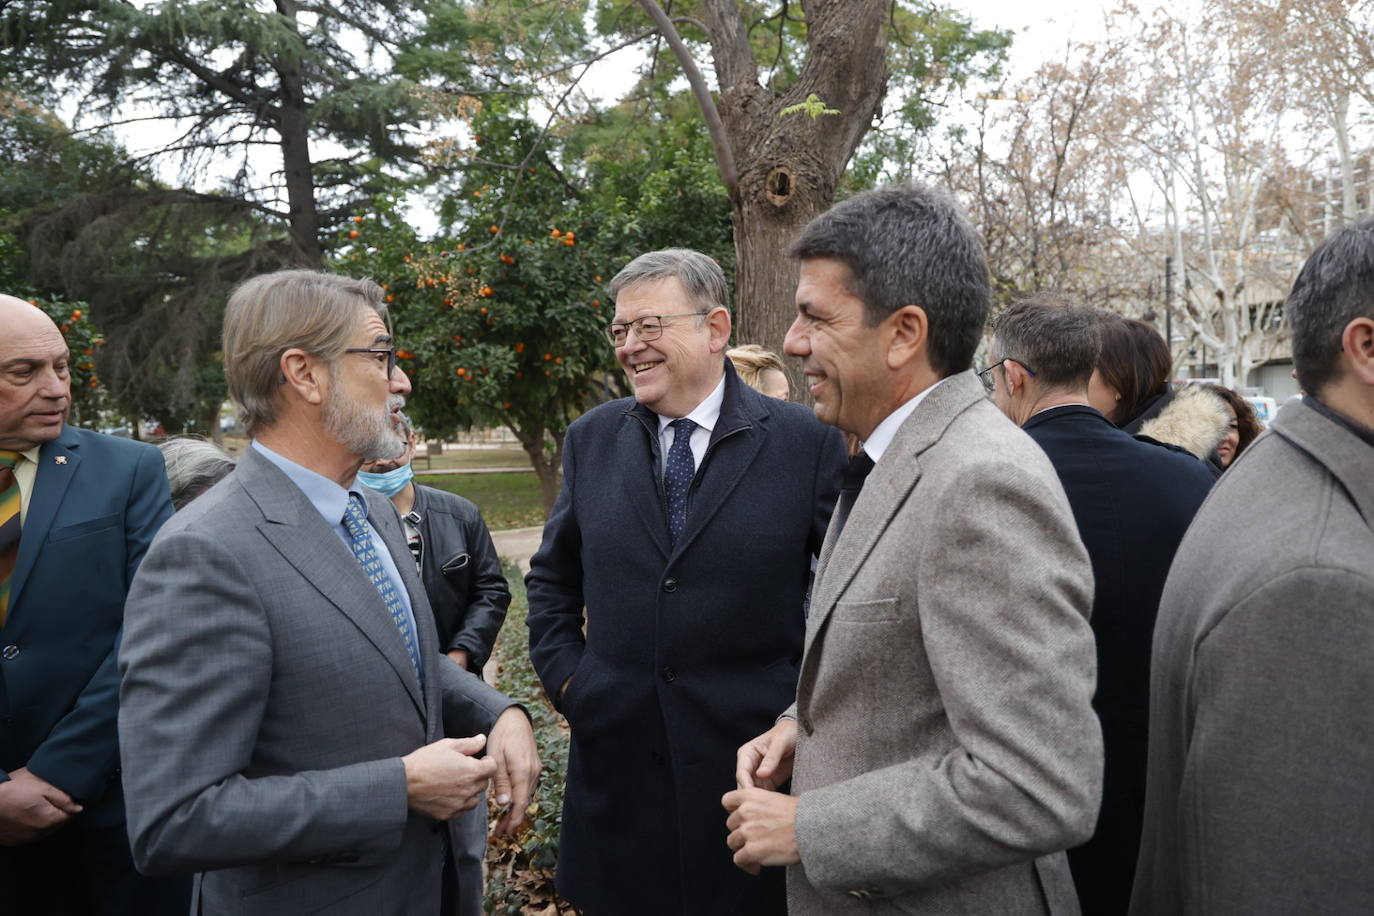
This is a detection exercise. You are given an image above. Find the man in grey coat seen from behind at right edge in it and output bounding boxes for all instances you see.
[1131,220,1374,916]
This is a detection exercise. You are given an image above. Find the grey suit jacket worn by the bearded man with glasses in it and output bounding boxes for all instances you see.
[120,449,510,916]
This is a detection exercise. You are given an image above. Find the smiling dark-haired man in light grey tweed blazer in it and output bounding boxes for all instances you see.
[724,187,1102,915]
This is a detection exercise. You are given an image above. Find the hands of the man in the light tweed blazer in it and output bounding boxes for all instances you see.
[720,718,801,875]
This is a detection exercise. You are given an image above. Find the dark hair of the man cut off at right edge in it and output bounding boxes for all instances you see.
[1283,218,1374,396]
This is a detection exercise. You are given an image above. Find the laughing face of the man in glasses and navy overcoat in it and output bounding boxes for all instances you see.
[611,277,730,417]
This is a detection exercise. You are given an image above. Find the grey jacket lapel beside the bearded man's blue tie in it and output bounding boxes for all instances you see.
[234,448,426,720]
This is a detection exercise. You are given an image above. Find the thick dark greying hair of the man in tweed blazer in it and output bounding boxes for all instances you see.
[789,184,992,375]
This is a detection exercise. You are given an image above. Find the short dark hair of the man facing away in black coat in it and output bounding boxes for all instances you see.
[989,293,1102,387]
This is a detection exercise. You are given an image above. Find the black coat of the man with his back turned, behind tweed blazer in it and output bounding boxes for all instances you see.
[1022,405,1213,916]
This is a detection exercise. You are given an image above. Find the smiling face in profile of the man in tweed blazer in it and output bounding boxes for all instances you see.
[783,258,890,439]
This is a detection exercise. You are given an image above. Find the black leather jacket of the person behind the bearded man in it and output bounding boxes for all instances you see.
[411,483,511,676]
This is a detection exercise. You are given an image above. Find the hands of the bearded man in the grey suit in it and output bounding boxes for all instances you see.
[401,706,539,834]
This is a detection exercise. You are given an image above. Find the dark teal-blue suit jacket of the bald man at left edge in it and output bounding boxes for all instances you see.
[0,426,172,824]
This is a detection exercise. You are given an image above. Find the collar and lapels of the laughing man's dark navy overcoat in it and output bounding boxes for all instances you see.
[624,360,769,559]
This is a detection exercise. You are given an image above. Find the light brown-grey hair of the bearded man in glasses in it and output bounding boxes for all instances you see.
[224,271,386,435]
